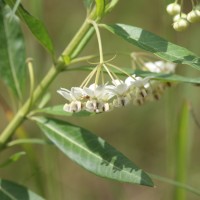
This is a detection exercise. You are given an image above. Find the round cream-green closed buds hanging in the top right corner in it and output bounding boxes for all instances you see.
[166,0,200,31]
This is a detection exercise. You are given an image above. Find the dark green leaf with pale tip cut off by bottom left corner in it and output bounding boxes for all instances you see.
[0,179,44,200]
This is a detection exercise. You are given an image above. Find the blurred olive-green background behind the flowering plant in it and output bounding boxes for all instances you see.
[0,0,200,200]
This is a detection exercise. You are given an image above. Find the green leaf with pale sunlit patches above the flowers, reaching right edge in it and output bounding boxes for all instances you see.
[102,24,200,70]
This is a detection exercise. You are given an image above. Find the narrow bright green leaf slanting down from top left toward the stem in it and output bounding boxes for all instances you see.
[5,0,54,56]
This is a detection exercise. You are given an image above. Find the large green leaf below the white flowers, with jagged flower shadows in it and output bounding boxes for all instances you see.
[33,117,153,186]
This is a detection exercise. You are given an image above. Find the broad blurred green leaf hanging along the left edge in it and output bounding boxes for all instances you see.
[0,3,26,98]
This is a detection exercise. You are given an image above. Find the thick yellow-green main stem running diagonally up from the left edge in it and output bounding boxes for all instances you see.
[0,9,99,149]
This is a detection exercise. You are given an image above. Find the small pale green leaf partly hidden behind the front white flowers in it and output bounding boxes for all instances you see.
[33,105,95,117]
